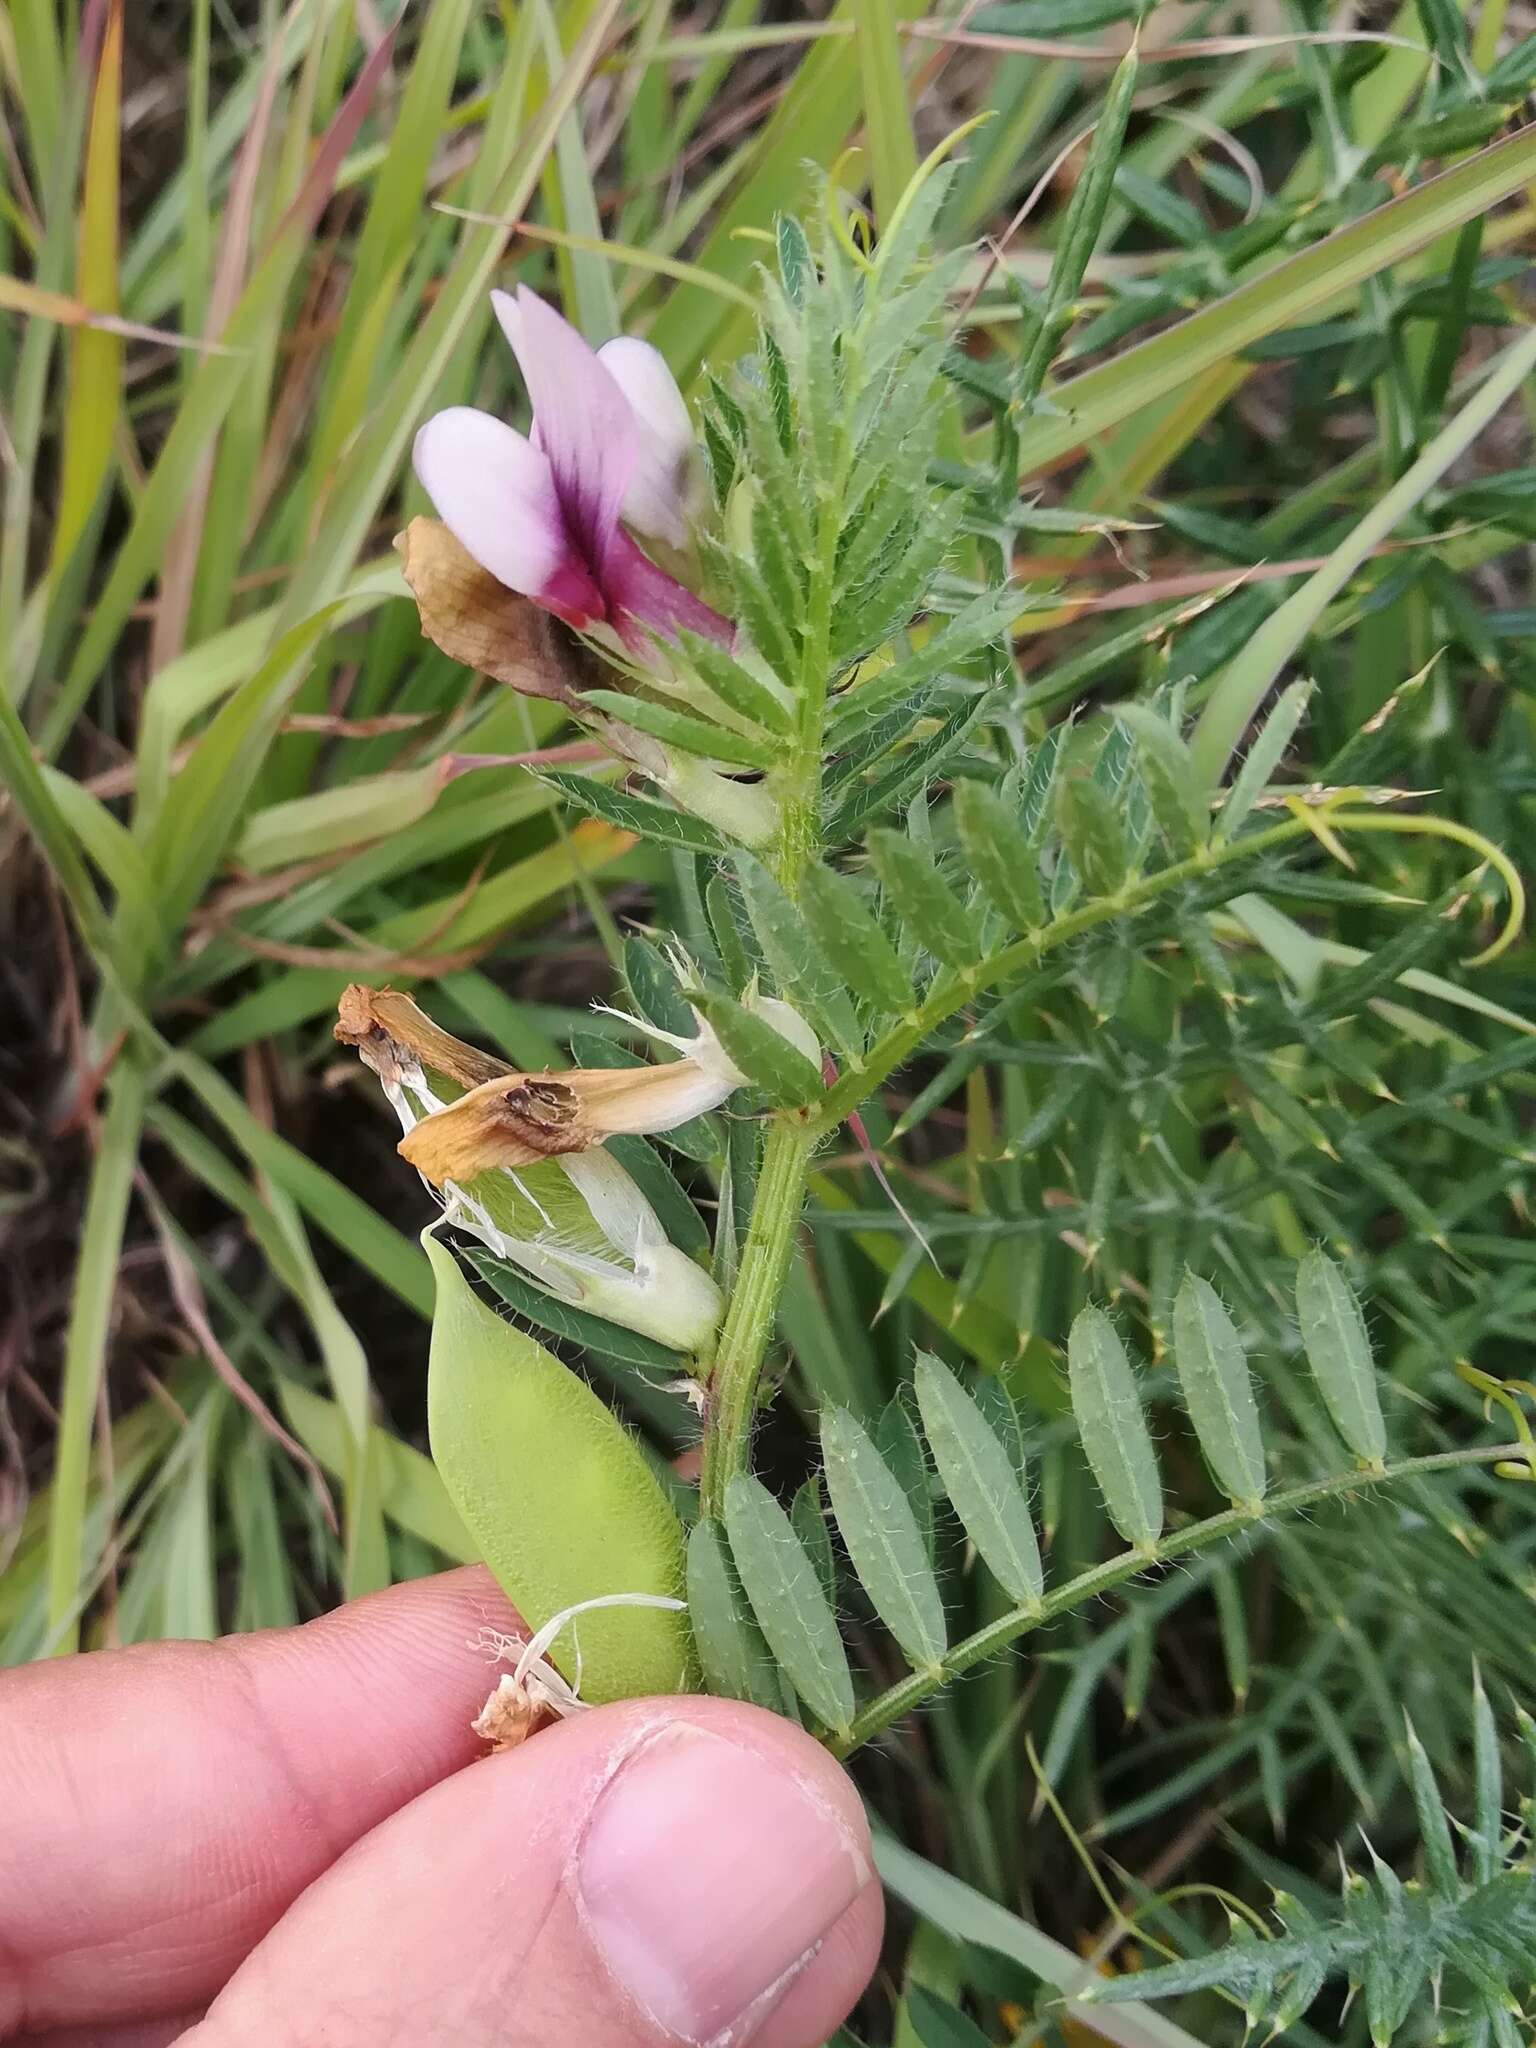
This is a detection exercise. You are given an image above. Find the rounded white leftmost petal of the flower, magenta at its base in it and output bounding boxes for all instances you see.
[412,406,604,625]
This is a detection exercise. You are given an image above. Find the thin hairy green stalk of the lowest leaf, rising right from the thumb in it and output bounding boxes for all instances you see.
[821,1444,1526,1757]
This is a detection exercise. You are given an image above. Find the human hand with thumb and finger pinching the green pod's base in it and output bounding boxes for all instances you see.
[0,1569,883,2048]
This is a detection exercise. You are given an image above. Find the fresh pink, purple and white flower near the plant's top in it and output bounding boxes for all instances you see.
[414,285,731,653]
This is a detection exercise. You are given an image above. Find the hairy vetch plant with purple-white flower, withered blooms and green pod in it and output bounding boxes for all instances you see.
[338,151,1536,1755]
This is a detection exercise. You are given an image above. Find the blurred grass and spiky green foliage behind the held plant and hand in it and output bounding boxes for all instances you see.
[0,0,1536,2040]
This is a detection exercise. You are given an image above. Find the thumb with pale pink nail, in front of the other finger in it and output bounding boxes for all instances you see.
[184,1698,883,2048]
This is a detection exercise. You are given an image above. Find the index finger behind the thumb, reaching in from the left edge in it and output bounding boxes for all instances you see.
[0,1567,518,2036]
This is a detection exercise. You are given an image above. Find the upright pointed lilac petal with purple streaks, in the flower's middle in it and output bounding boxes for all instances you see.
[492,285,639,575]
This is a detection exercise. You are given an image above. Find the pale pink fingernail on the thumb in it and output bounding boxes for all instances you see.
[575,1726,870,2048]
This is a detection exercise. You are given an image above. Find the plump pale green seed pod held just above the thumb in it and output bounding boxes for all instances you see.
[422,1231,694,1704]
